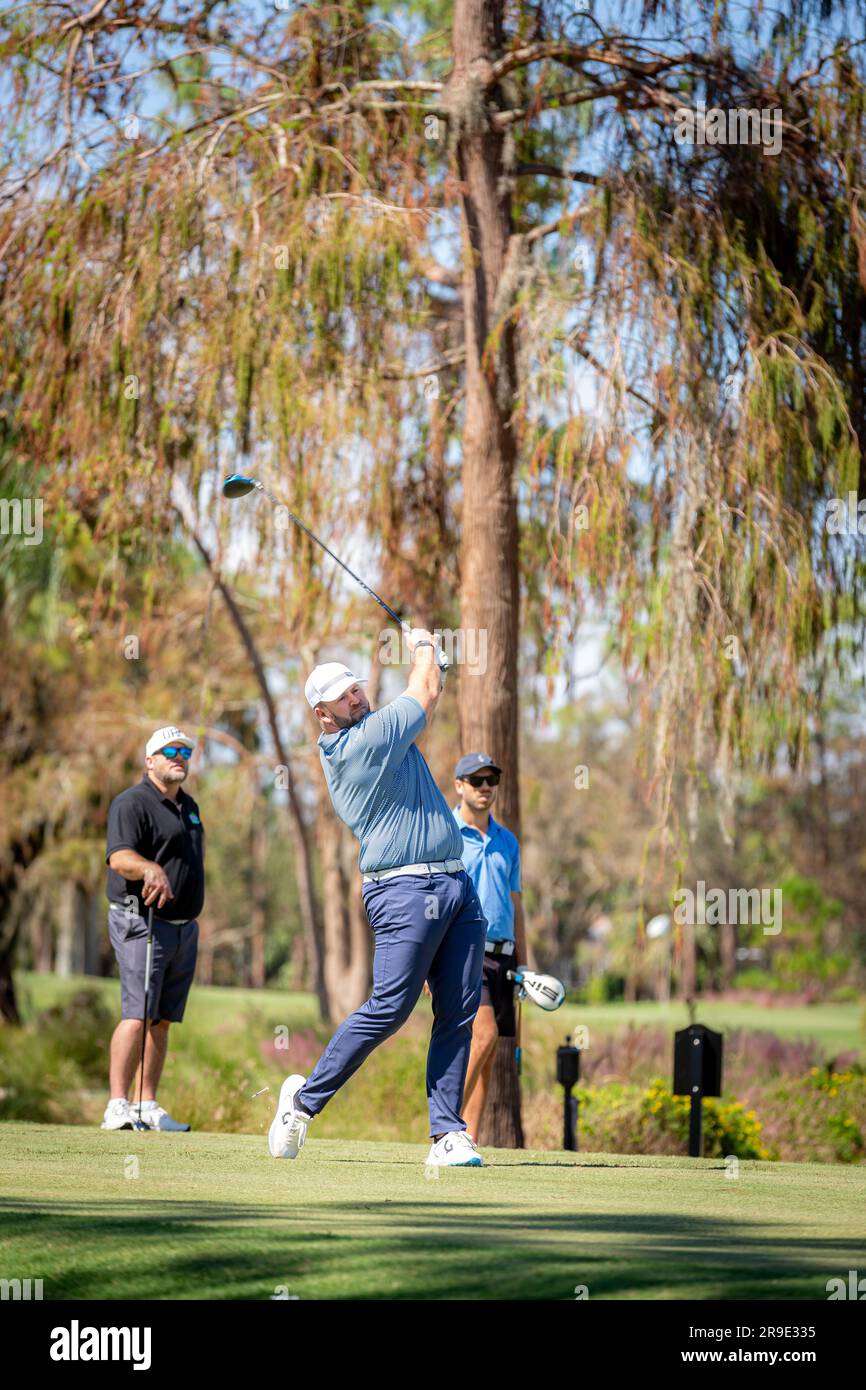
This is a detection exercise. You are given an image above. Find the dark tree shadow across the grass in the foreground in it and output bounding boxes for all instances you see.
[0,1198,855,1300]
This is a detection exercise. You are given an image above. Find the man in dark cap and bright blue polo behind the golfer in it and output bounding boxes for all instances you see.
[455,753,527,1134]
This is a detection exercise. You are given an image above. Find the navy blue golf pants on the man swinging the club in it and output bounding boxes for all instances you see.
[295,869,487,1134]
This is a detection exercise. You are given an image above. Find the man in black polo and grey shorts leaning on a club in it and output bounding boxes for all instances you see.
[101,724,204,1130]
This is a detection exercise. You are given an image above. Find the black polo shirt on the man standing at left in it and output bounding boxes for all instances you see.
[106,773,204,922]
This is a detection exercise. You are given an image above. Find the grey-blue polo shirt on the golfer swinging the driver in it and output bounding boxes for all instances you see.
[318,695,463,873]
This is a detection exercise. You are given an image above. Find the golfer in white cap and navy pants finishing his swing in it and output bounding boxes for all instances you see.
[268,628,487,1166]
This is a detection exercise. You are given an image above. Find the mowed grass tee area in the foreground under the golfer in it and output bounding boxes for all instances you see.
[0,1123,866,1300]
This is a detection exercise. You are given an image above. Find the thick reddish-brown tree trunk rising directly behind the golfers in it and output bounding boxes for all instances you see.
[448,0,523,1148]
